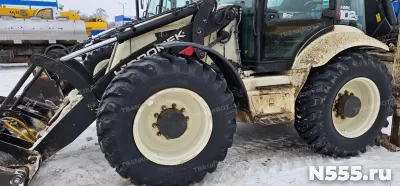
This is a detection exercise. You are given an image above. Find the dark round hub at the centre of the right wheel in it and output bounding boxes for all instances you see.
[335,91,361,118]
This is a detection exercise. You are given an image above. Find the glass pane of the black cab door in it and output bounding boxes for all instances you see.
[263,0,326,61]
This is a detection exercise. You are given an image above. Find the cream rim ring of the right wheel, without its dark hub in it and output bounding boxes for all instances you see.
[332,77,381,138]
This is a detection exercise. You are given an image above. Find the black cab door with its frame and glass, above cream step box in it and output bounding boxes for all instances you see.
[241,0,335,72]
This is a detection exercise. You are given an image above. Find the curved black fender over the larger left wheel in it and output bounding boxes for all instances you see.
[156,41,250,111]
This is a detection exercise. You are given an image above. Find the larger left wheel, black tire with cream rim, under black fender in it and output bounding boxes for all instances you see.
[97,55,236,185]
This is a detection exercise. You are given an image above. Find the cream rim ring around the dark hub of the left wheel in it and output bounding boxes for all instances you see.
[133,88,213,166]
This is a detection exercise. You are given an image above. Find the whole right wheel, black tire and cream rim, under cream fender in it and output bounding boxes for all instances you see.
[295,52,394,157]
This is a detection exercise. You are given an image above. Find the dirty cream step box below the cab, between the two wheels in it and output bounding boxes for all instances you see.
[236,75,295,125]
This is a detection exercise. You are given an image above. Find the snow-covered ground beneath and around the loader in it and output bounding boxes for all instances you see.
[0,68,400,186]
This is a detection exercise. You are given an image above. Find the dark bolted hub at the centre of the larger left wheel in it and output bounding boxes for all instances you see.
[157,108,187,139]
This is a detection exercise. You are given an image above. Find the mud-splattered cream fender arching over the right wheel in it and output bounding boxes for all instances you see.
[292,25,389,69]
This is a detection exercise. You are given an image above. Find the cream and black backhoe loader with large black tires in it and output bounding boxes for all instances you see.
[0,0,398,186]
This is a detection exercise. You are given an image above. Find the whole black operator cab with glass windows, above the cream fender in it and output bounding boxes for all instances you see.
[223,0,398,72]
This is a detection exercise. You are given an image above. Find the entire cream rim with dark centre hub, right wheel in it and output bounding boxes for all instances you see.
[332,77,380,138]
